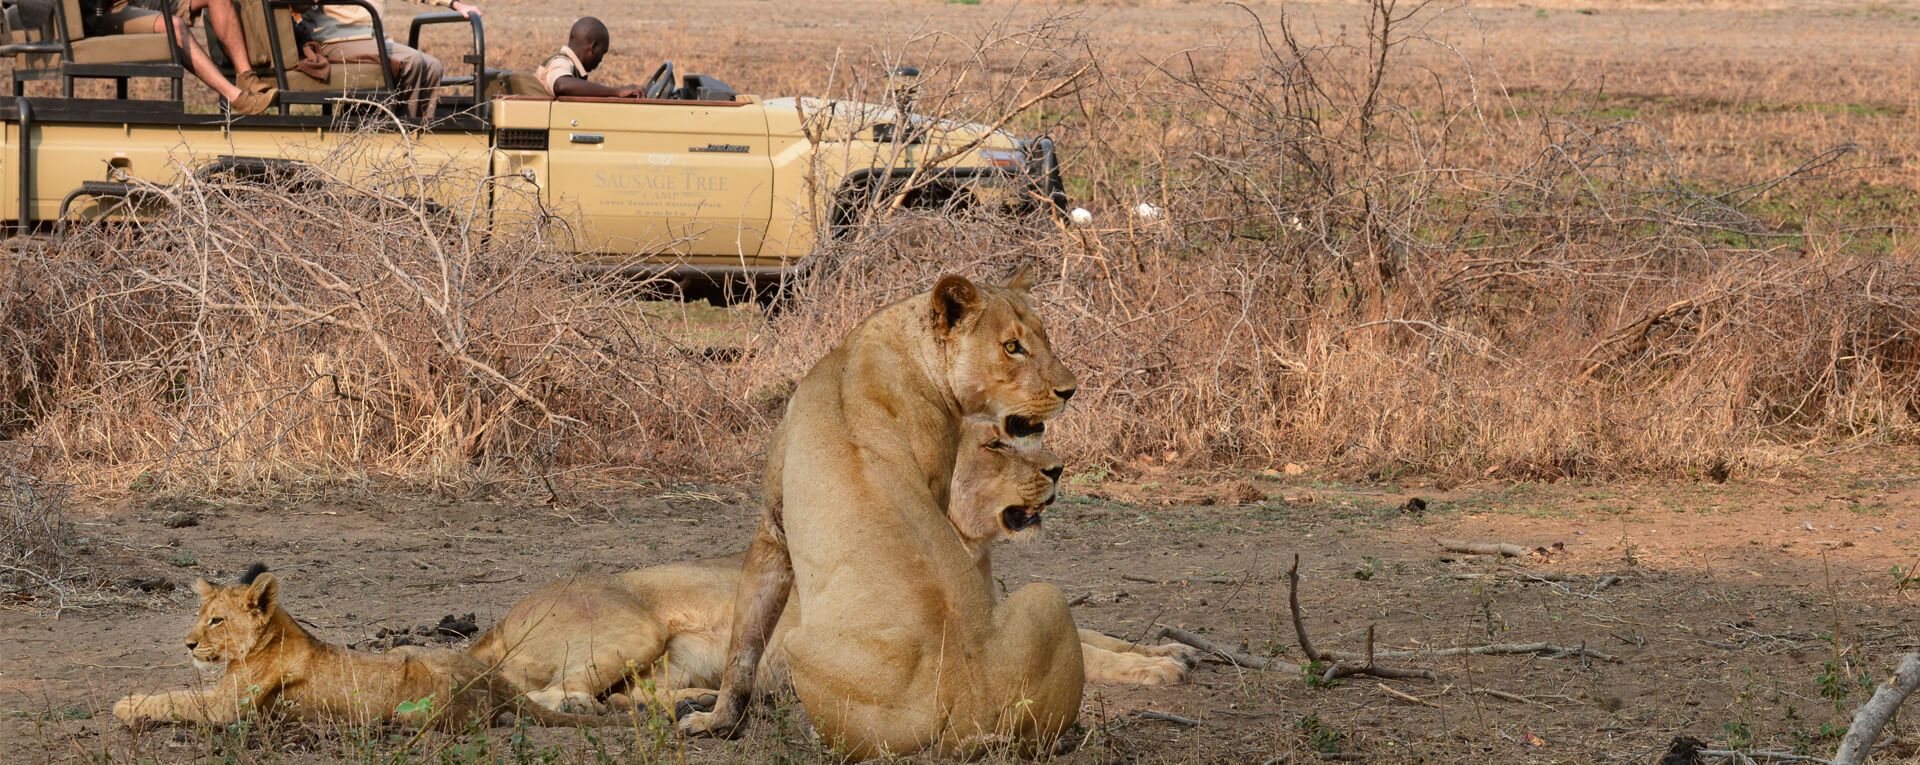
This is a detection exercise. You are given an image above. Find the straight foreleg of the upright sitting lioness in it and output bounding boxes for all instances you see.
[680,513,793,738]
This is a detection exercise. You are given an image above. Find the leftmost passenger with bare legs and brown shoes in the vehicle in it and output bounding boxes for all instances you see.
[81,0,275,113]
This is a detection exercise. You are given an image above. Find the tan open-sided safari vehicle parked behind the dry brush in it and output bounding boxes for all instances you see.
[0,0,1066,297]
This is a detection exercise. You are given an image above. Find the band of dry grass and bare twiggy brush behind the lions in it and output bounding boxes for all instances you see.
[0,4,1920,492]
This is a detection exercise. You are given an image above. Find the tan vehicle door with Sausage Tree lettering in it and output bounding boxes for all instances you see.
[547,98,774,265]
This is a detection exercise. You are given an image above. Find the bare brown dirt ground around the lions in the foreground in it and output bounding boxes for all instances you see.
[11,452,1920,763]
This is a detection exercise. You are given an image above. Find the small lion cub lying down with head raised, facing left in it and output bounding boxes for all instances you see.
[113,563,618,728]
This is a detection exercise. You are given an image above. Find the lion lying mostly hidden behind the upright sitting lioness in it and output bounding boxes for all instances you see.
[468,415,1192,713]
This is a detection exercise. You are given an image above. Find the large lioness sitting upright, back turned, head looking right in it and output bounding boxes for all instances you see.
[682,265,1085,757]
